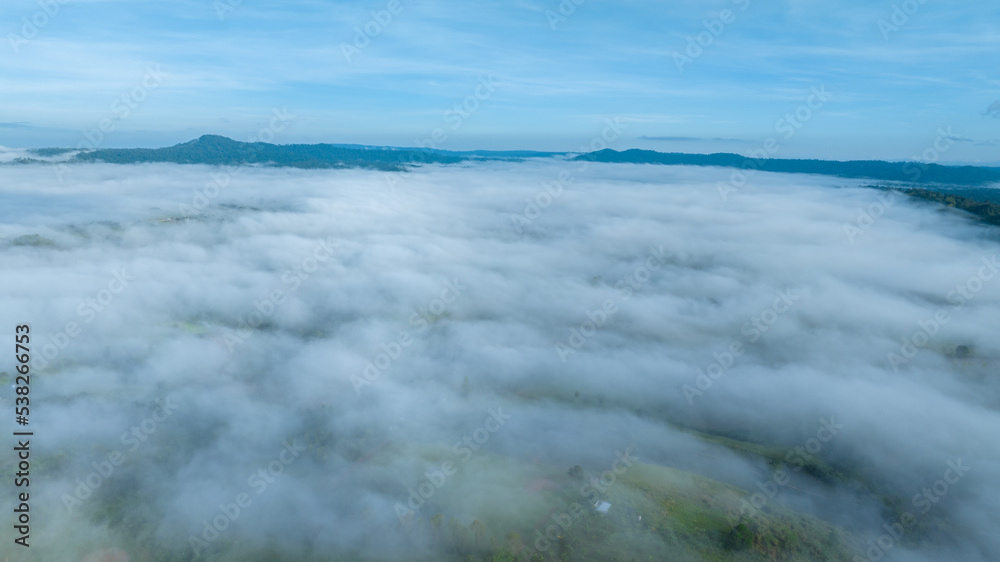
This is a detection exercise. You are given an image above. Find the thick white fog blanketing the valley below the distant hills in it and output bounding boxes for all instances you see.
[0,160,1000,562]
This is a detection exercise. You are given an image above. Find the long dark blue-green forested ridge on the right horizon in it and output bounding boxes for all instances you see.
[576,149,1000,186]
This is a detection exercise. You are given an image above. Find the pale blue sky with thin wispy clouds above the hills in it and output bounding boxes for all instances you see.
[0,0,1000,163]
